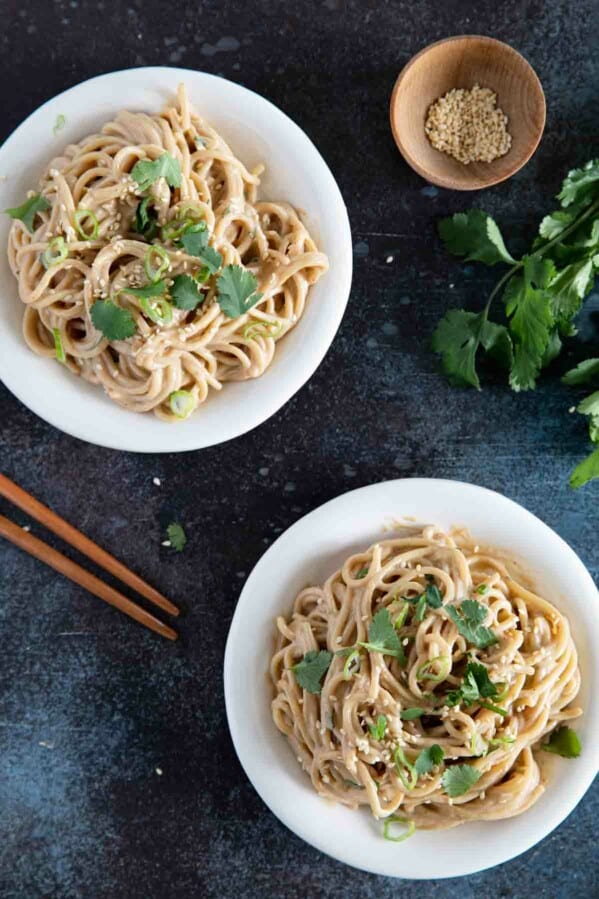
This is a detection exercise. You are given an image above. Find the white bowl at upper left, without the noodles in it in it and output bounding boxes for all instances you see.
[0,67,352,453]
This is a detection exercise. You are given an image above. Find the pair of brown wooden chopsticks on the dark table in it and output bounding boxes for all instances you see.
[0,474,179,640]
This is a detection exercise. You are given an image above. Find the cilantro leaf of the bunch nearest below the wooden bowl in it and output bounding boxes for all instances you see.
[439,209,516,265]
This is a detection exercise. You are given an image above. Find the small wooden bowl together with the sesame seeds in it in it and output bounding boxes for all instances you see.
[390,35,545,190]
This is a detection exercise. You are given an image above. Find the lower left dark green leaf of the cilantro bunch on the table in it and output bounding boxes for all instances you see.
[432,309,513,390]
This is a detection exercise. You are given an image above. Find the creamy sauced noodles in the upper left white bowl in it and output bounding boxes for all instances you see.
[8,86,328,420]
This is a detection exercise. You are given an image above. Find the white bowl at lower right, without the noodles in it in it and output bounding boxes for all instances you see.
[224,478,599,878]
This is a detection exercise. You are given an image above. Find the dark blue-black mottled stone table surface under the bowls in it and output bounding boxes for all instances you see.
[0,0,599,899]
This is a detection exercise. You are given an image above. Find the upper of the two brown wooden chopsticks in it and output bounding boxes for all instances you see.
[0,474,179,620]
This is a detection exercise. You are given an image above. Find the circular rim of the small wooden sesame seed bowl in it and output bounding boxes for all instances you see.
[389,34,547,190]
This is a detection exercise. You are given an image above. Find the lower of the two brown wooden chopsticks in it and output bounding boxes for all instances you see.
[0,512,177,640]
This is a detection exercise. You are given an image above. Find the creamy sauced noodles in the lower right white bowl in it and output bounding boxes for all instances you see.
[270,526,581,828]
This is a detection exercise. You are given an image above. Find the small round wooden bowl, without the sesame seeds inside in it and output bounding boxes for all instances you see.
[390,35,545,190]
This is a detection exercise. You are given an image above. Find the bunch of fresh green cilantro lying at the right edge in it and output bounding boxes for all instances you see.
[433,160,599,488]
